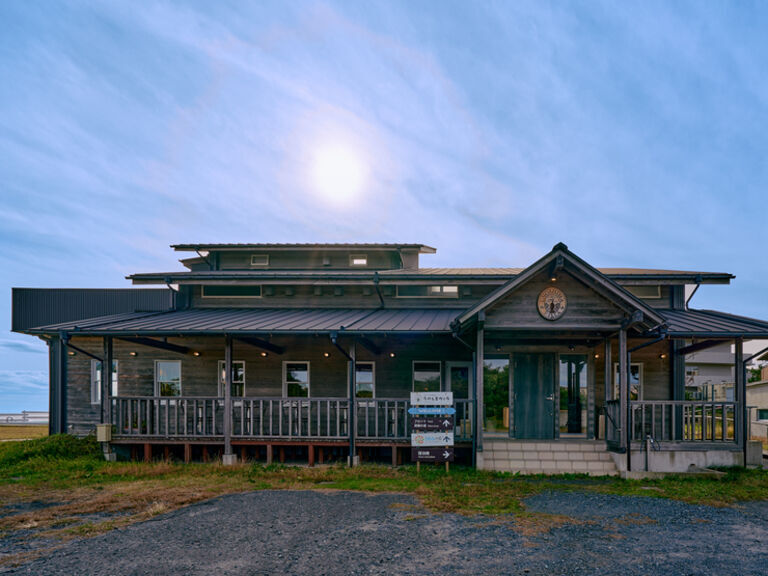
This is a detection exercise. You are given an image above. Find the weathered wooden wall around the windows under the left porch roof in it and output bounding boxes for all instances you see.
[67,335,472,434]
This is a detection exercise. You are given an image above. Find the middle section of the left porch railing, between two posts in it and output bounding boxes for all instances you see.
[232,398,349,439]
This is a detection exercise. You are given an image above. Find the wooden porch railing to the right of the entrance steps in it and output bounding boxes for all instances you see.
[629,400,738,443]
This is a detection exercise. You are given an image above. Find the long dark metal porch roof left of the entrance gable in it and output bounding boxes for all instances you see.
[29,308,461,335]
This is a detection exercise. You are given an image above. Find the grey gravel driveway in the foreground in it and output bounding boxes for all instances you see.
[1,491,768,576]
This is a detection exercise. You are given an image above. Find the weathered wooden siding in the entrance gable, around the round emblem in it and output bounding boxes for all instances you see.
[485,271,624,330]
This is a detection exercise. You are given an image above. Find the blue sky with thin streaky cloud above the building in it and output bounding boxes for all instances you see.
[0,0,768,412]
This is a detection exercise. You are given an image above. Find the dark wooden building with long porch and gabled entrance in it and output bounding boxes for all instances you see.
[13,244,768,474]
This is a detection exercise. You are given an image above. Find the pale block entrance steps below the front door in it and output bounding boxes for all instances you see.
[478,439,619,476]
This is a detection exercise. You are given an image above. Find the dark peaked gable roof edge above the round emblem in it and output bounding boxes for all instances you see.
[456,242,664,328]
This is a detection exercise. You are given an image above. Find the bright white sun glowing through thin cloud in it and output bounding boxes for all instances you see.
[312,144,368,204]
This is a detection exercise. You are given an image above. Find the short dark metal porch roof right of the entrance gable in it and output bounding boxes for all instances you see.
[658,309,768,338]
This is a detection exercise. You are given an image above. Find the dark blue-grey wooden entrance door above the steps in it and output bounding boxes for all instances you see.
[512,354,555,438]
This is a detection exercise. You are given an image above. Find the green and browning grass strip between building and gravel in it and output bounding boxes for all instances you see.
[0,436,768,565]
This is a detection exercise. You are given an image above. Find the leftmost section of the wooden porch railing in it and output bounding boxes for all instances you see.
[110,396,224,438]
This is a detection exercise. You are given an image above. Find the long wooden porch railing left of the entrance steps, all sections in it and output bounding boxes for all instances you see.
[110,396,473,442]
